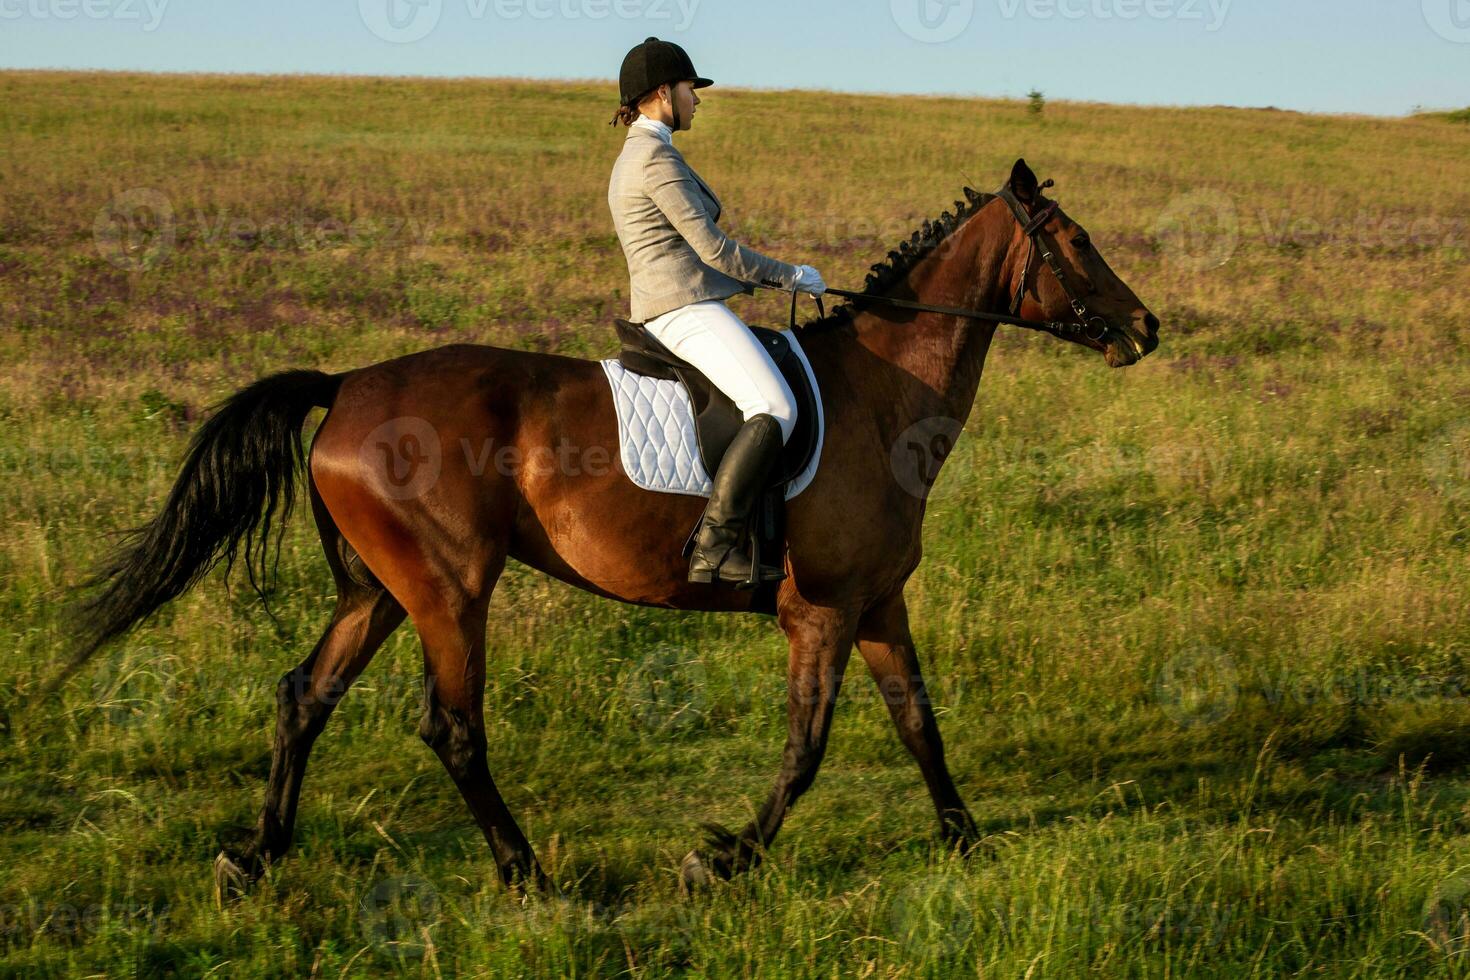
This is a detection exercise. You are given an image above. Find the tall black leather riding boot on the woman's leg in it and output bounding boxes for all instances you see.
[689,414,782,583]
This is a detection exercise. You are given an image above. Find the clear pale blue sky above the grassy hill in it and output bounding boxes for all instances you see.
[0,0,1470,115]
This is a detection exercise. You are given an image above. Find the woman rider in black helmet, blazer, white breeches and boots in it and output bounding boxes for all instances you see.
[607,38,826,583]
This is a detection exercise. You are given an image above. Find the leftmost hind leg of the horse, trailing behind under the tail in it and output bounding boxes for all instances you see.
[215,488,404,898]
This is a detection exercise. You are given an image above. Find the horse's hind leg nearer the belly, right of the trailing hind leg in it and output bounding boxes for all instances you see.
[413,557,548,890]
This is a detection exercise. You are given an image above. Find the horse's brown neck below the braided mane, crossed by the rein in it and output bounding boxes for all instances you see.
[834,212,1007,422]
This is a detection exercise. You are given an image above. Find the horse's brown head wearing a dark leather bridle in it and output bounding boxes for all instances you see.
[1001,160,1158,367]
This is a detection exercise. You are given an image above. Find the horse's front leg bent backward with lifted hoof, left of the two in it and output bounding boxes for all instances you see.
[684,598,857,884]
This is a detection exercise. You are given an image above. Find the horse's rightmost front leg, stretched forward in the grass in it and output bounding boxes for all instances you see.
[857,592,979,848]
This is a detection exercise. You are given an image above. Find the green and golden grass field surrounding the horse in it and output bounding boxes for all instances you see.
[0,73,1470,977]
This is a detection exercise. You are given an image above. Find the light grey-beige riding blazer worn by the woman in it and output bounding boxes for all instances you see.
[607,126,798,323]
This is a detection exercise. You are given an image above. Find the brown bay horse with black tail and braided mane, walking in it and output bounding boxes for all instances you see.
[63,162,1158,892]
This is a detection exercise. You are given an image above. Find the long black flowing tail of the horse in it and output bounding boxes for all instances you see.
[46,370,341,691]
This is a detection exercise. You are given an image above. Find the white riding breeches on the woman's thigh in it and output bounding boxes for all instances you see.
[644,300,797,444]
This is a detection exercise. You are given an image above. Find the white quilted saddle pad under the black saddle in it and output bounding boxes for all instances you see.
[603,331,826,500]
